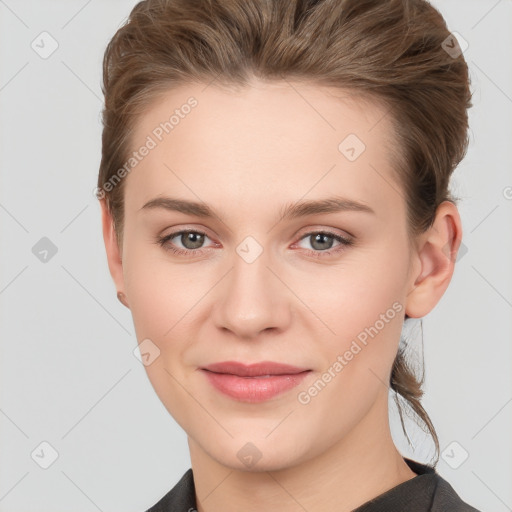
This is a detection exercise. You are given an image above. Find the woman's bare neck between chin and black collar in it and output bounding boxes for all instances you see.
[189,393,416,512]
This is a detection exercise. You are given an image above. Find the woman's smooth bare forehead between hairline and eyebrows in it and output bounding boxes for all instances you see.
[125,80,400,219]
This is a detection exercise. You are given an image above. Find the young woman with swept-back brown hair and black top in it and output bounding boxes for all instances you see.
[98,0,482,512]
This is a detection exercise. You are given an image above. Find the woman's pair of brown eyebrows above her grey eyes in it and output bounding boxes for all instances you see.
[141,196,375,220]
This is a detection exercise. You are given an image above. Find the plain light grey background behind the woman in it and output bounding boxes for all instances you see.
[0,0,512,512]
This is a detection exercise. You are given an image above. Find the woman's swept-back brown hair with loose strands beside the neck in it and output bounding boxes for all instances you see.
[98,0,471,465]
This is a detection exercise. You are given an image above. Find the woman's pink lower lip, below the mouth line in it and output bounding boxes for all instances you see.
[202,370,310,403]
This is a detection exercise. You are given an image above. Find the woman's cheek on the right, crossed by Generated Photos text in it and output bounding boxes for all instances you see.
[303,242,408,388]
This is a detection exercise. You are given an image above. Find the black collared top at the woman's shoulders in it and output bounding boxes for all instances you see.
[146,457,480,512]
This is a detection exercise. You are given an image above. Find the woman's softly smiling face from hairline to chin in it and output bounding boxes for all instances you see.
[108,81,420,471]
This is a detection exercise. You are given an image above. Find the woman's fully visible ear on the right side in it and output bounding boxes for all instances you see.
[405,201,462,318]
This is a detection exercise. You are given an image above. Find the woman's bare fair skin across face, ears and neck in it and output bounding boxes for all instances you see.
[101,80,462,512]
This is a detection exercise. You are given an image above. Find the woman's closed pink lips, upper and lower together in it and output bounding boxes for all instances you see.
[200,361,311,403]
